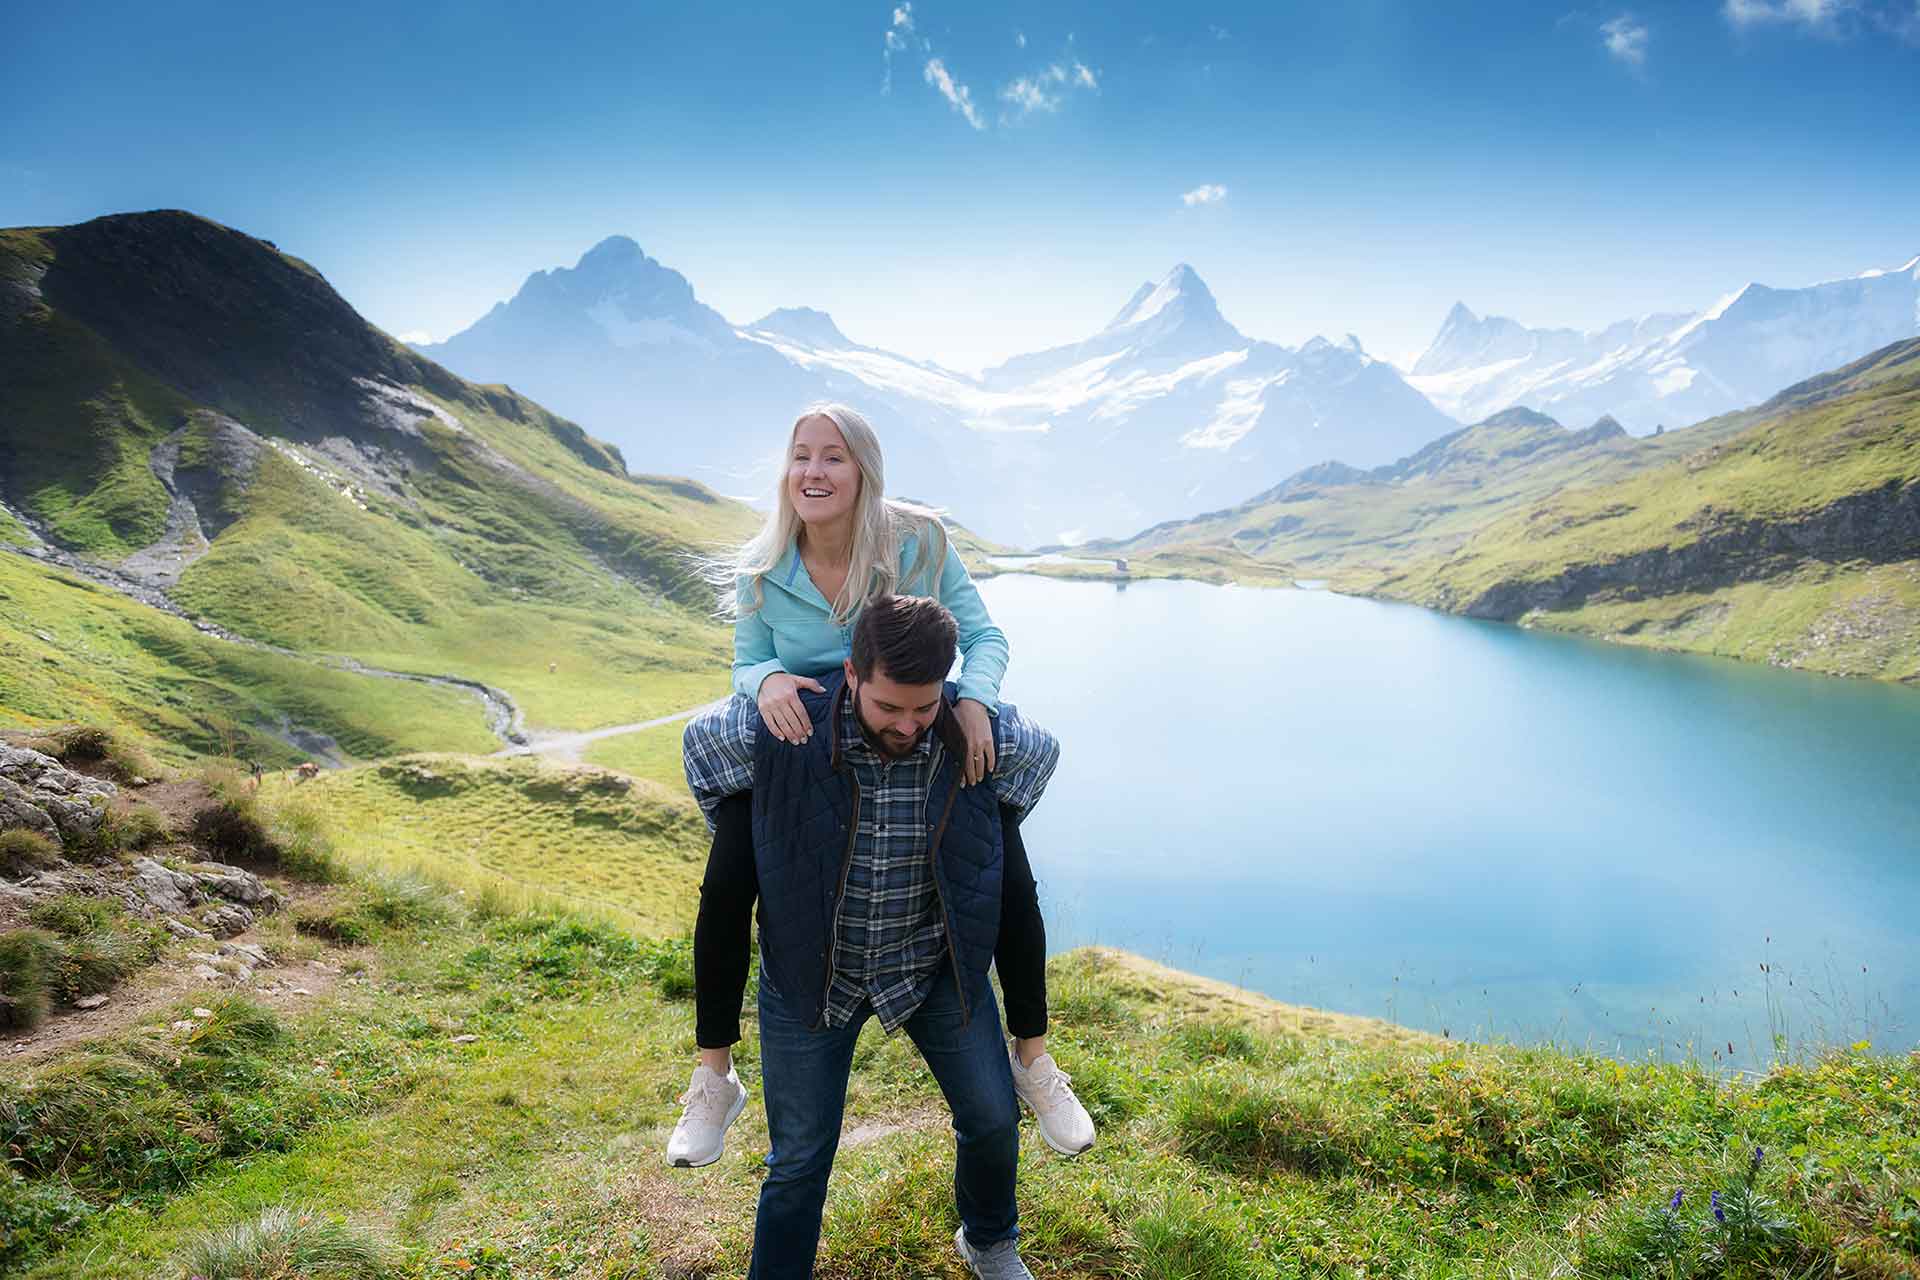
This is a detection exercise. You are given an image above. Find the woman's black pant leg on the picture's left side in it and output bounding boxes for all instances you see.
[693,791,760,1050]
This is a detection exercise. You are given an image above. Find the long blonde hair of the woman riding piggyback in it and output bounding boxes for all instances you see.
[705,405,947,624]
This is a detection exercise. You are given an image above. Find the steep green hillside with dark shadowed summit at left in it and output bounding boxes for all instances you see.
[0,213,753,747]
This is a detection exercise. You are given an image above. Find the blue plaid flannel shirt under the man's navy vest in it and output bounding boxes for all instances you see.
[685,689,1060,1032]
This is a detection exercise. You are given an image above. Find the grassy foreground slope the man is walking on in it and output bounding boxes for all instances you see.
[15,760,1920,1280]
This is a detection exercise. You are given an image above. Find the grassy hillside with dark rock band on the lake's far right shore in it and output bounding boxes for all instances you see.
[1100,342,1920,679]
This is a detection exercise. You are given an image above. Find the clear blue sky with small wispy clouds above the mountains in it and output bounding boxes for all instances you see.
[0,0,1920,367]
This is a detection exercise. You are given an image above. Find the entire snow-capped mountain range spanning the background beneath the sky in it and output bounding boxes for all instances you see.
[420,236,1920,545]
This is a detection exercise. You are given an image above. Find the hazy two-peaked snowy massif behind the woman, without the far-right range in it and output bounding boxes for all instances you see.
[420,236,1453,545]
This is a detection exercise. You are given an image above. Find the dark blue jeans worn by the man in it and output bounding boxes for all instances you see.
[747,965,1020,1280]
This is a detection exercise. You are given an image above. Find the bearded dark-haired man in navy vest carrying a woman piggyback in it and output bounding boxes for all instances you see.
[687,597,1058,1280]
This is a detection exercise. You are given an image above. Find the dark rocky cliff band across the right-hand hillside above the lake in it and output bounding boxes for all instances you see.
[1459,482,1920,622]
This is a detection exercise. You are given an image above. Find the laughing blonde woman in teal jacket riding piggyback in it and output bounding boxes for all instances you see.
[666,405,1092,1167]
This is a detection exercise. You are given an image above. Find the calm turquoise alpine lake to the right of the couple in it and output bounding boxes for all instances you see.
[981,576,1920,1069]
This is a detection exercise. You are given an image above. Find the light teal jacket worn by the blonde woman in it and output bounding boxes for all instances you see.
[733,537,1006,714]
